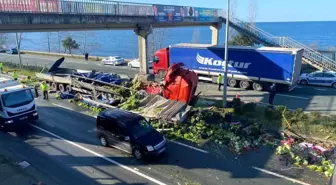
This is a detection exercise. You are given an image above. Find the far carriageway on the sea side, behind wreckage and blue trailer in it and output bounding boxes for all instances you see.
[0,54,336,115]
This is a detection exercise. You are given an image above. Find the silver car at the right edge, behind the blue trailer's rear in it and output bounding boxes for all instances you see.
[300,71,336,88]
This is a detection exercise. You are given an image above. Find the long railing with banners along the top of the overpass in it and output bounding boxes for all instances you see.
[0,0,221,21]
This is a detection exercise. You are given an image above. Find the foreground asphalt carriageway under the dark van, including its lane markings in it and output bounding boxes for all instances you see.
[0,99,326,185]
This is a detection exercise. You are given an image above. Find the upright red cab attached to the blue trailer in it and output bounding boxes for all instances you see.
[153,48,169,77]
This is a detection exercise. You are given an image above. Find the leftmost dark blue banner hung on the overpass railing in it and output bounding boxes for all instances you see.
[153,5,185,22]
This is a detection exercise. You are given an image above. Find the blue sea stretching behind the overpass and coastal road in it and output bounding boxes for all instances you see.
[6,21,336,59]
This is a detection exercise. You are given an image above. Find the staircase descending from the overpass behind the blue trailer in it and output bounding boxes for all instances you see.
[223,18,336,71]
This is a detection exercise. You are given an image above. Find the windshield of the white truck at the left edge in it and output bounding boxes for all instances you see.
[1,89,34,108]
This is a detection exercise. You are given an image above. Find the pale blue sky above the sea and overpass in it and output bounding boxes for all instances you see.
[116,0,336,22]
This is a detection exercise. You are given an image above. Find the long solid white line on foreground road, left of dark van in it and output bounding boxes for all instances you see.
[30,124,166,185]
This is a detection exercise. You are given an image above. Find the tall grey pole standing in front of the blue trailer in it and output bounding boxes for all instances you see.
[223,0,230,108]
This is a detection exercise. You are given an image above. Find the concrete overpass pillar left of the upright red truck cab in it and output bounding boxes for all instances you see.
[134,25,153,75]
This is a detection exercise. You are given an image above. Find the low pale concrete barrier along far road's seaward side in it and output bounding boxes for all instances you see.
[21,50,131,62]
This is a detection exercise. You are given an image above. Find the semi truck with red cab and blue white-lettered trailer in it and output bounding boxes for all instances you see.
[153,44,303,91]
